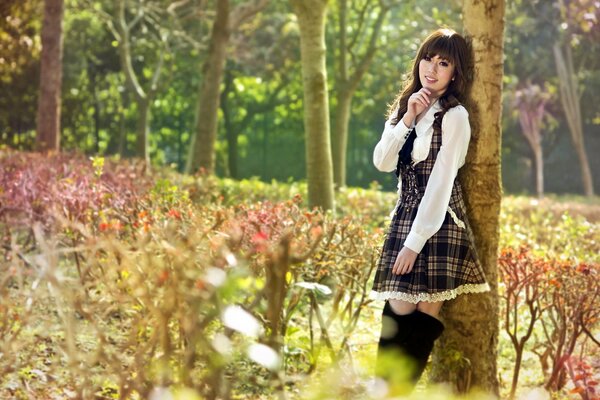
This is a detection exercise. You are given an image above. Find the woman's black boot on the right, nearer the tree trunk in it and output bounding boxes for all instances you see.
[406,310,444,384]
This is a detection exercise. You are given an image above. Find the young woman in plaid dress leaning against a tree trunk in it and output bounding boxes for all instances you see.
[372,29,489,390]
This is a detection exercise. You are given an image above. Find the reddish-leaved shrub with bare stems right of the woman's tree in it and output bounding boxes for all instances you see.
[499,245,600,399]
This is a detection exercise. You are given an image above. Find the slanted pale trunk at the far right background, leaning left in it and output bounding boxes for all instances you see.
[554,44,594,196]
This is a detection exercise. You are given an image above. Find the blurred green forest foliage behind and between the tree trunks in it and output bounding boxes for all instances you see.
[0,0,600,194]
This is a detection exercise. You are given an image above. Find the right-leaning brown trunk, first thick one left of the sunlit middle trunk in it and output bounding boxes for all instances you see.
[185,0,229,174]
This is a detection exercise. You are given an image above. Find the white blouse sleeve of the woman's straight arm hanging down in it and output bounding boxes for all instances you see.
[404,106,471,253]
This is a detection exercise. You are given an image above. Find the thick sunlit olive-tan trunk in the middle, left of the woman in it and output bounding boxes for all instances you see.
[291,0,335,210]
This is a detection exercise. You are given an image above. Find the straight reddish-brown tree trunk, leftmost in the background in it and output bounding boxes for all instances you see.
[36,0,64,151]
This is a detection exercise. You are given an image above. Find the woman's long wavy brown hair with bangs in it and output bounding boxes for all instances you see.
[387,28,473,129]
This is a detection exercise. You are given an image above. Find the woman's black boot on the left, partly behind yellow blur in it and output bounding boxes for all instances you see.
[375,301,416,385]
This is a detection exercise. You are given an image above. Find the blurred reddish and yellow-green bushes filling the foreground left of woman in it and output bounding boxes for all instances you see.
[0,155,376,398]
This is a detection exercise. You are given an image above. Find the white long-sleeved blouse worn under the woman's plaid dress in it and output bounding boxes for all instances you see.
[373,100,471,253]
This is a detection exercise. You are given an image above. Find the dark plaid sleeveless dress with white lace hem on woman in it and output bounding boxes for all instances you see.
[371,119,490,303]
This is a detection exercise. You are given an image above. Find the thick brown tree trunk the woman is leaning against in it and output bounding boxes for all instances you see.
[433,0,504,395]
